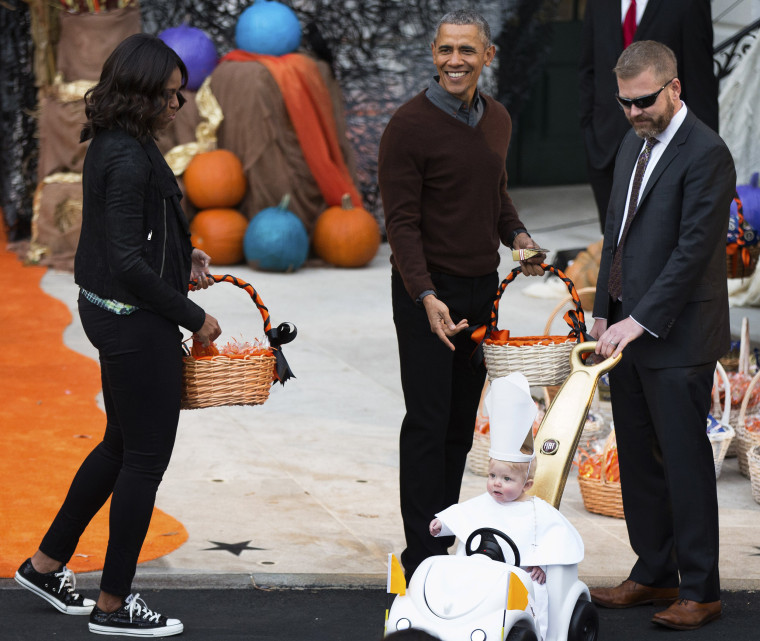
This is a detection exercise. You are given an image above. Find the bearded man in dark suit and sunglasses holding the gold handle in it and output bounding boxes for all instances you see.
[591,41,736,630]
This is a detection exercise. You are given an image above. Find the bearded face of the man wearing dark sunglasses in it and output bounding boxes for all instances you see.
[618,68,681,138]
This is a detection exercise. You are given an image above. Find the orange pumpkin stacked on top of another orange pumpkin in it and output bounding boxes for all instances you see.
[184,149,246,209]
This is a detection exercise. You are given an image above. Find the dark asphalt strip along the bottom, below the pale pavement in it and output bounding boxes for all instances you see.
[0,581,760,641]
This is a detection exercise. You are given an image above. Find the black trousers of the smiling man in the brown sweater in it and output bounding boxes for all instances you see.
[391,270,499,579]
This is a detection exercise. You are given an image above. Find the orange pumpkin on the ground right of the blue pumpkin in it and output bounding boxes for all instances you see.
[311,194,380,267]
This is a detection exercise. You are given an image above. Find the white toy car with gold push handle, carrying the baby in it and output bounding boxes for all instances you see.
[386,341,621,641]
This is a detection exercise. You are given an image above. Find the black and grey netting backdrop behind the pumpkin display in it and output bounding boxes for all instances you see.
[0,0,558,239]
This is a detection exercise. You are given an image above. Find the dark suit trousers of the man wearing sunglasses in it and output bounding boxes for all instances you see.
[610,306,720,603]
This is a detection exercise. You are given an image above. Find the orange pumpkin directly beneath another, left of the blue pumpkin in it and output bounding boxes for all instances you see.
[190,209,248,265]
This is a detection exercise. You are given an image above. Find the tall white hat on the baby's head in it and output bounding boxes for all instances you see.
[485,372,538,463]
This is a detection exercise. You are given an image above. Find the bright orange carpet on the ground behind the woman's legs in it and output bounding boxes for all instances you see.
[0,222,187,577]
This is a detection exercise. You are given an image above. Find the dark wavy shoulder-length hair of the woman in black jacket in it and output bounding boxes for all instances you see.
[79,33,187,142]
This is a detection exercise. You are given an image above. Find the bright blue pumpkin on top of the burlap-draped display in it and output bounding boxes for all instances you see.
[235,0,301,56]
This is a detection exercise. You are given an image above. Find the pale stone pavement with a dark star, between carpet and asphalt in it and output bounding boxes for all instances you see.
[7,186,760,639]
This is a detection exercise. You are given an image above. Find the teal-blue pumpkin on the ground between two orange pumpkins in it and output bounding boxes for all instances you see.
[243,194,309,272]
